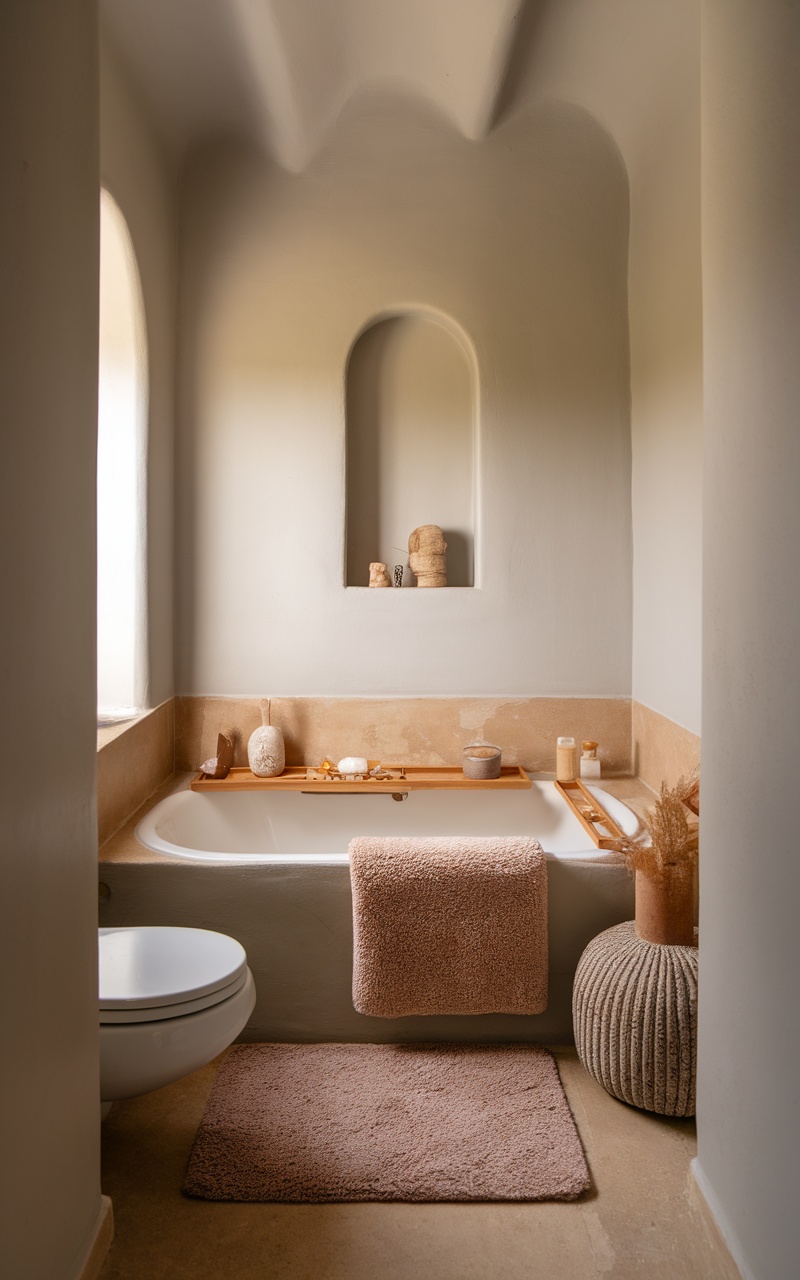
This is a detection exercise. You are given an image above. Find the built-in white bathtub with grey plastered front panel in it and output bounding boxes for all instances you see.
[101,780,636,1043]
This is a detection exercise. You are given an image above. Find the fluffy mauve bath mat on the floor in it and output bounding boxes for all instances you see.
[183,1044,589,1203]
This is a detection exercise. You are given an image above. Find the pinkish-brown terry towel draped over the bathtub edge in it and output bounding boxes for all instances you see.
[349,836,548,1018]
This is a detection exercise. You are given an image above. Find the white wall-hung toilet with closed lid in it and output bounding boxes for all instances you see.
[99,925,256,1117]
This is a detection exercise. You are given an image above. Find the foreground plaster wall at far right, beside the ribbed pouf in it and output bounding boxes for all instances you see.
[696,0,800,1280]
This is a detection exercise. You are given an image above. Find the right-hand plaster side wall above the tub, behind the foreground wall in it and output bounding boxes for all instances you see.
[628,15,703,733]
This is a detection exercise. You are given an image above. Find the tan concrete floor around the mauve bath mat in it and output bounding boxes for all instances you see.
[101,1050,736,1280]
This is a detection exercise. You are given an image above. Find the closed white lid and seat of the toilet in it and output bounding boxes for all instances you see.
[99,925,247,1010]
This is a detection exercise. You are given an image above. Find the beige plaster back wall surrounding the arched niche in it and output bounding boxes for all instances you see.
[177,93,631,696]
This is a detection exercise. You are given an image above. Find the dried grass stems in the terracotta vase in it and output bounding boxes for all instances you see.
[616,768,700,882]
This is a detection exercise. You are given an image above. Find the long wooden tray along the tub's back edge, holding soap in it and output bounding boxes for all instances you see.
[189,764,531,795]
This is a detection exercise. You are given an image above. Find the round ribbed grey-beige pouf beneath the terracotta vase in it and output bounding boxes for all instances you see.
[572,920,698,1116]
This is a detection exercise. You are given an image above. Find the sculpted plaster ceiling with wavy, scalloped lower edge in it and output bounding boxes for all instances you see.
[101,0,698,173]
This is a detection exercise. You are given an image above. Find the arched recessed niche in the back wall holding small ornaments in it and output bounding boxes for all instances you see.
[344,307,479,588]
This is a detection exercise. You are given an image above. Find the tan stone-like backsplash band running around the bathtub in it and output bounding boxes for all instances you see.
[97,696,700,845]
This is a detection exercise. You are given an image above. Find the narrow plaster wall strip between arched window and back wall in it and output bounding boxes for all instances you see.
[100,28,177,707]
